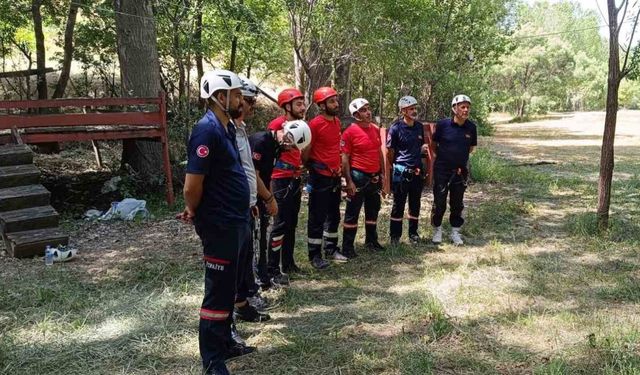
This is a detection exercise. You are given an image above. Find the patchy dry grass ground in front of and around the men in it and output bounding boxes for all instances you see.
[0,112,640,375]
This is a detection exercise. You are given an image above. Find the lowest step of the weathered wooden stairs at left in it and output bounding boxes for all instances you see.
[4,228,69,258]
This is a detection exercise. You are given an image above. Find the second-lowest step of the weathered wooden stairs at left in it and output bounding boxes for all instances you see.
[0,206,60,233]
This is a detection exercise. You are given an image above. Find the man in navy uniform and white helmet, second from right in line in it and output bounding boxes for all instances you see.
[387,96,427,244]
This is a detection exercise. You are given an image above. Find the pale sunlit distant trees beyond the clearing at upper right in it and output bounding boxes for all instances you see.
[491,1,607,117]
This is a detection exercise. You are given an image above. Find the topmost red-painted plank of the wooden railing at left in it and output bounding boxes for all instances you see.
[0,97,160,109]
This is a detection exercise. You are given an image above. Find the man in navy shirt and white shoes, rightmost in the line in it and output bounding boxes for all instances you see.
[431,95,478,246]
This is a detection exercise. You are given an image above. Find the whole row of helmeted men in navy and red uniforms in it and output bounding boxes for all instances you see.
[179,70,477,375]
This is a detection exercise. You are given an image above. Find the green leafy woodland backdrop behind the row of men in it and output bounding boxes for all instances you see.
[0,0,608,131]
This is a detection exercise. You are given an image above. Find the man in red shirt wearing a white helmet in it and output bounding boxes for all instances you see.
[340,98,384,258]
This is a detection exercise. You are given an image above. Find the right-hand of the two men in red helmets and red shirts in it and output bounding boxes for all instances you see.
[302,87,348,269]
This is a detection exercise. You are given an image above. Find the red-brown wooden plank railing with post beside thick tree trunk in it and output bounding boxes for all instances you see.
[0,92,175,205]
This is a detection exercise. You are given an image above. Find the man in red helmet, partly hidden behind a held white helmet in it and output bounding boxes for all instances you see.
[261,88,306,288]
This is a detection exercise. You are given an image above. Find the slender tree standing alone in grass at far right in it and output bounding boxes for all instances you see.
[597,0,640,230]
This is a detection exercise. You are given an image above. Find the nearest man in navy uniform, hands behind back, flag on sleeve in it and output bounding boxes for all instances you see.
[181,70,249,375]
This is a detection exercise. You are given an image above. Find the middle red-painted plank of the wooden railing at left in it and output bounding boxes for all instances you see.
[0,112,163,129]
